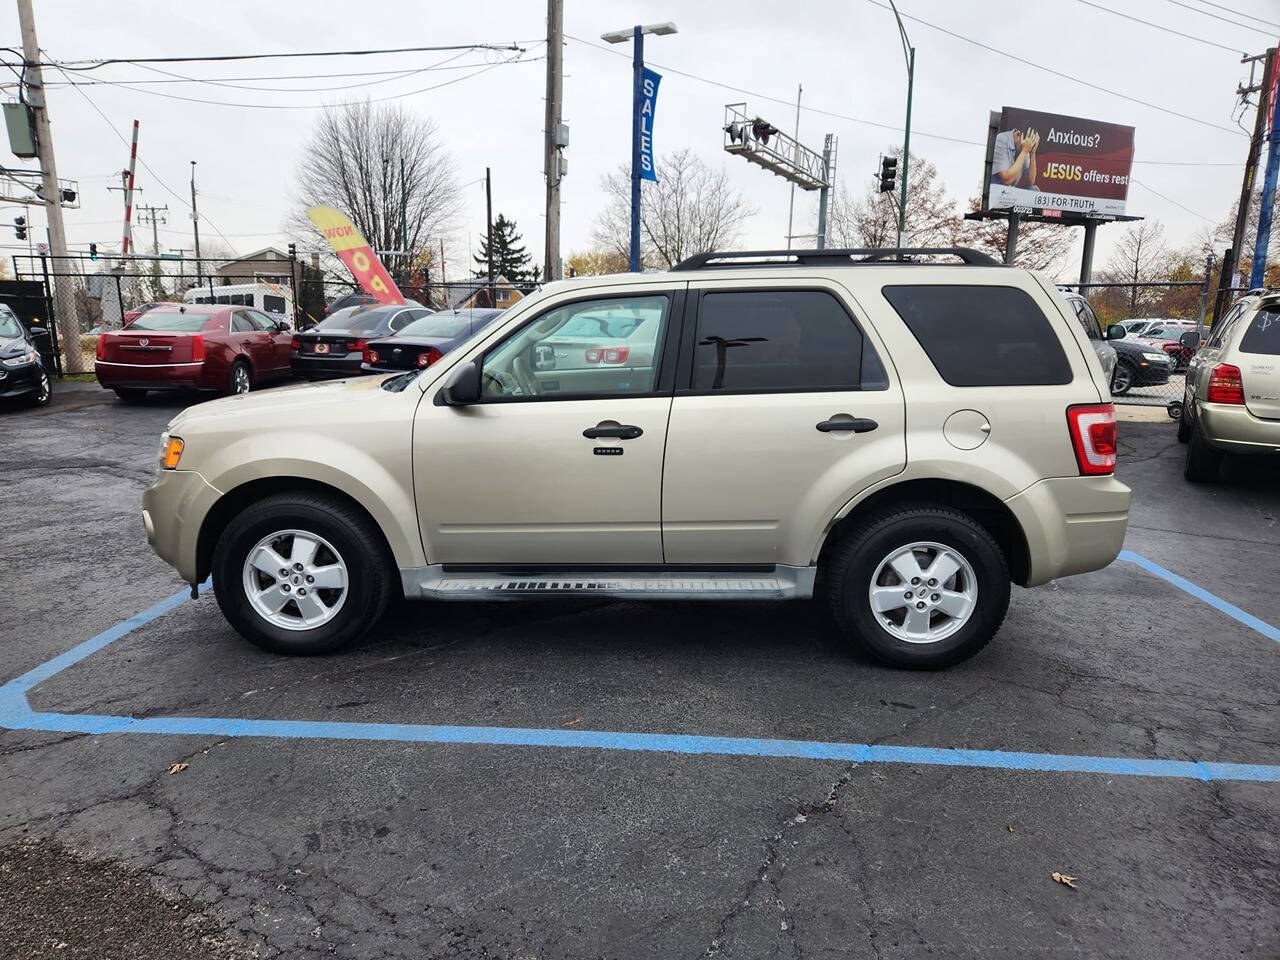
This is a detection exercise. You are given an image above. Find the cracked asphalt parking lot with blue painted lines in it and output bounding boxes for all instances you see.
[0,387,1280,959]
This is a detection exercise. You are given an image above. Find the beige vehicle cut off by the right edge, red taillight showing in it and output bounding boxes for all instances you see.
[1178,292,1280,483]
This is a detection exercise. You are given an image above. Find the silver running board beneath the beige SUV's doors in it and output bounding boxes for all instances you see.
[401,564,817,600]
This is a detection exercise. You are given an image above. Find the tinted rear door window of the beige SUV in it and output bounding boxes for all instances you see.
[692,291,888,393]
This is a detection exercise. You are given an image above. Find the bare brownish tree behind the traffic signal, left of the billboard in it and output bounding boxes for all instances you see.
[827,147,957,247]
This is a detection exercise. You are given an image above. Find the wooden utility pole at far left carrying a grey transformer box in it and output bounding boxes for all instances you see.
[18,0,88,374]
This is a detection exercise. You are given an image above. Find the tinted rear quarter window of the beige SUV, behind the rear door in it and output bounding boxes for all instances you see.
[881,284,1073,387]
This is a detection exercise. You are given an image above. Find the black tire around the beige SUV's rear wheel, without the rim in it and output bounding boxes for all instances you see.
[822,504,1009,669]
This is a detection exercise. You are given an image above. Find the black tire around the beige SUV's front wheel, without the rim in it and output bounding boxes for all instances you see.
[212,493,396,657]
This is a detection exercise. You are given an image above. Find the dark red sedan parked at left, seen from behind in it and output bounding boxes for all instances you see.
[93,303,291,401]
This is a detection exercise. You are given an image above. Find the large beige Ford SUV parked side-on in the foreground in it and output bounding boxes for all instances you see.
[143,248,1129,667]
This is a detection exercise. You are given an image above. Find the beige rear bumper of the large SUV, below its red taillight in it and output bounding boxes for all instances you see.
[1005,476,1130,586]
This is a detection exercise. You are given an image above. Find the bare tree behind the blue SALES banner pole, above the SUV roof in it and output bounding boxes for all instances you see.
[593,147,755,269]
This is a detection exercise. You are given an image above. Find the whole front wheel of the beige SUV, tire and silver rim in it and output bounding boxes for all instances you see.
[212,494,393,655]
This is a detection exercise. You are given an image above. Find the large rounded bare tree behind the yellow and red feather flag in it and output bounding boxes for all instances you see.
[289,100,458,289]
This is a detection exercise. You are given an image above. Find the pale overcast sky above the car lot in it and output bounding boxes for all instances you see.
[0,0,1280,278]
